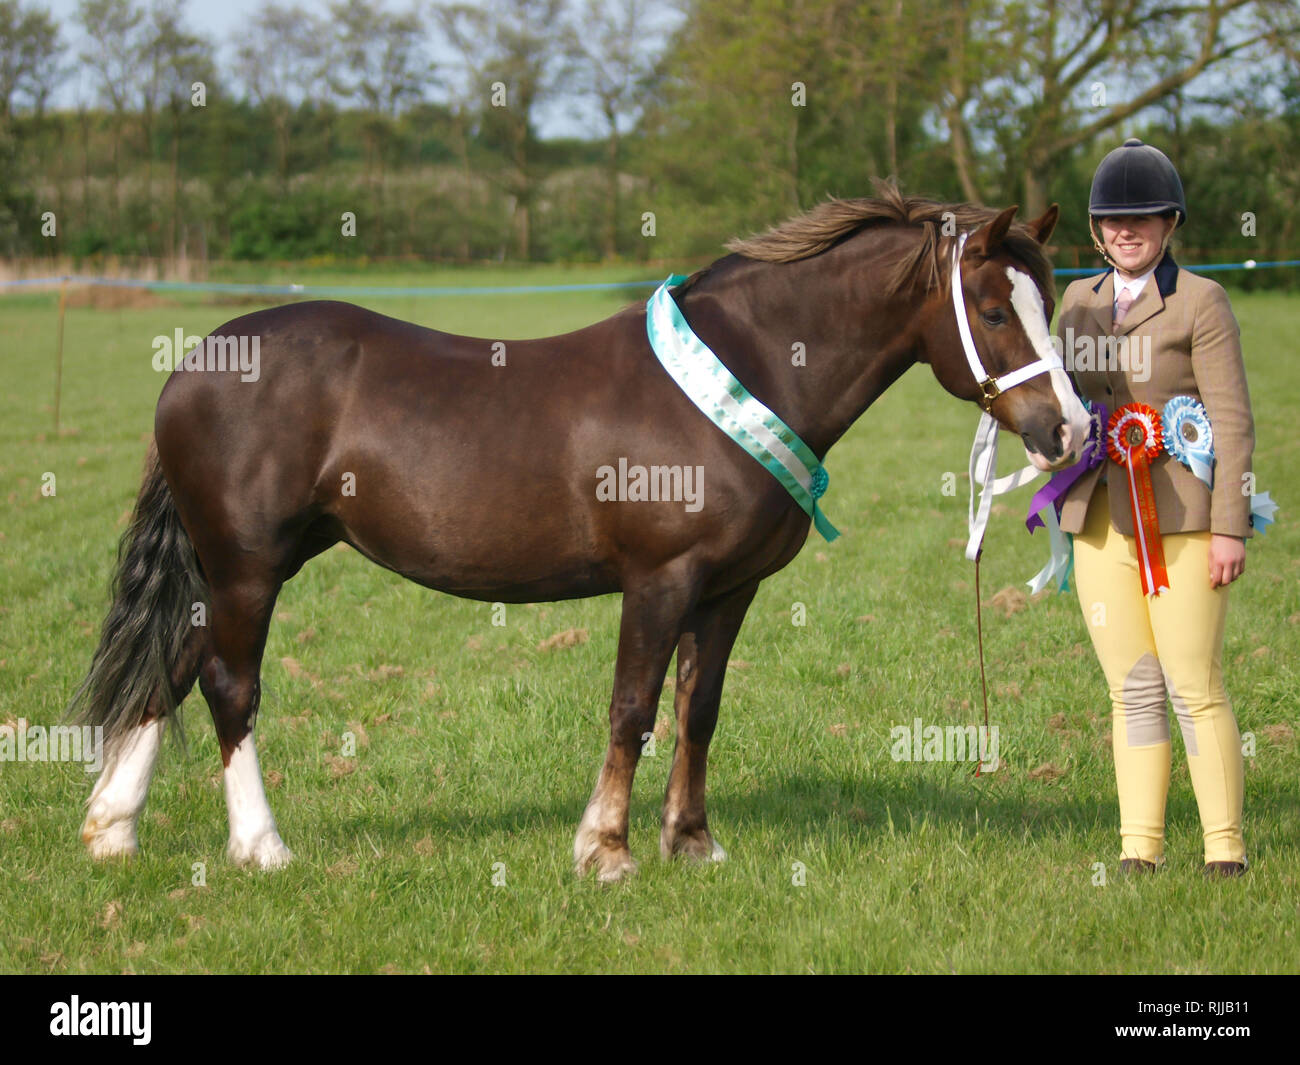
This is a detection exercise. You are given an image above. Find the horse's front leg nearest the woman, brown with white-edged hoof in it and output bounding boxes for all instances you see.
[659,581,758,862]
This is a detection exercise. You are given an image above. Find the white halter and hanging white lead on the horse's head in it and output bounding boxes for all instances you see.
[949,233,1061,562]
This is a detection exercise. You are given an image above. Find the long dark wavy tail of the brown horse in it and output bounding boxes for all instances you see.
[68,445,207,761]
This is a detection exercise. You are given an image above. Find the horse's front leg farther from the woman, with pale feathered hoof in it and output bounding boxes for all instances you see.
[573,564,698,882]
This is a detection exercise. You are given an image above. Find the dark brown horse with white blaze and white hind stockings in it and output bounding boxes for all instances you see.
[73,186,1087,880]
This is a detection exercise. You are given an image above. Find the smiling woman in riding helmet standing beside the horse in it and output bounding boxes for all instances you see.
[1057,139,1255,876]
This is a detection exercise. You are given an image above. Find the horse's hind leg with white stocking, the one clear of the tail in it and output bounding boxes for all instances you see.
[199,572,293,869]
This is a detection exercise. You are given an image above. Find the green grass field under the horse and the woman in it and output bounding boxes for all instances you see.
[0,269,1300,973]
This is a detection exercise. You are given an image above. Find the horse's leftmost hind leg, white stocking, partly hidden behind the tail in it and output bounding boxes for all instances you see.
[82,628,208,858]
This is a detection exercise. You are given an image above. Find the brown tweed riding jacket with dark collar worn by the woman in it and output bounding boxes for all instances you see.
[1057,251,1255,538]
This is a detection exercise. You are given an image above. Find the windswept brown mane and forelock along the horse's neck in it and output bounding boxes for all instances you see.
[727,179,1054,295]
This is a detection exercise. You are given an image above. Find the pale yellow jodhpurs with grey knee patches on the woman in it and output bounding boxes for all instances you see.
[1074,485,1245,863]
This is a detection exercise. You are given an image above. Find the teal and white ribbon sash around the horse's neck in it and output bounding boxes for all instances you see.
[646,274,840,541]
